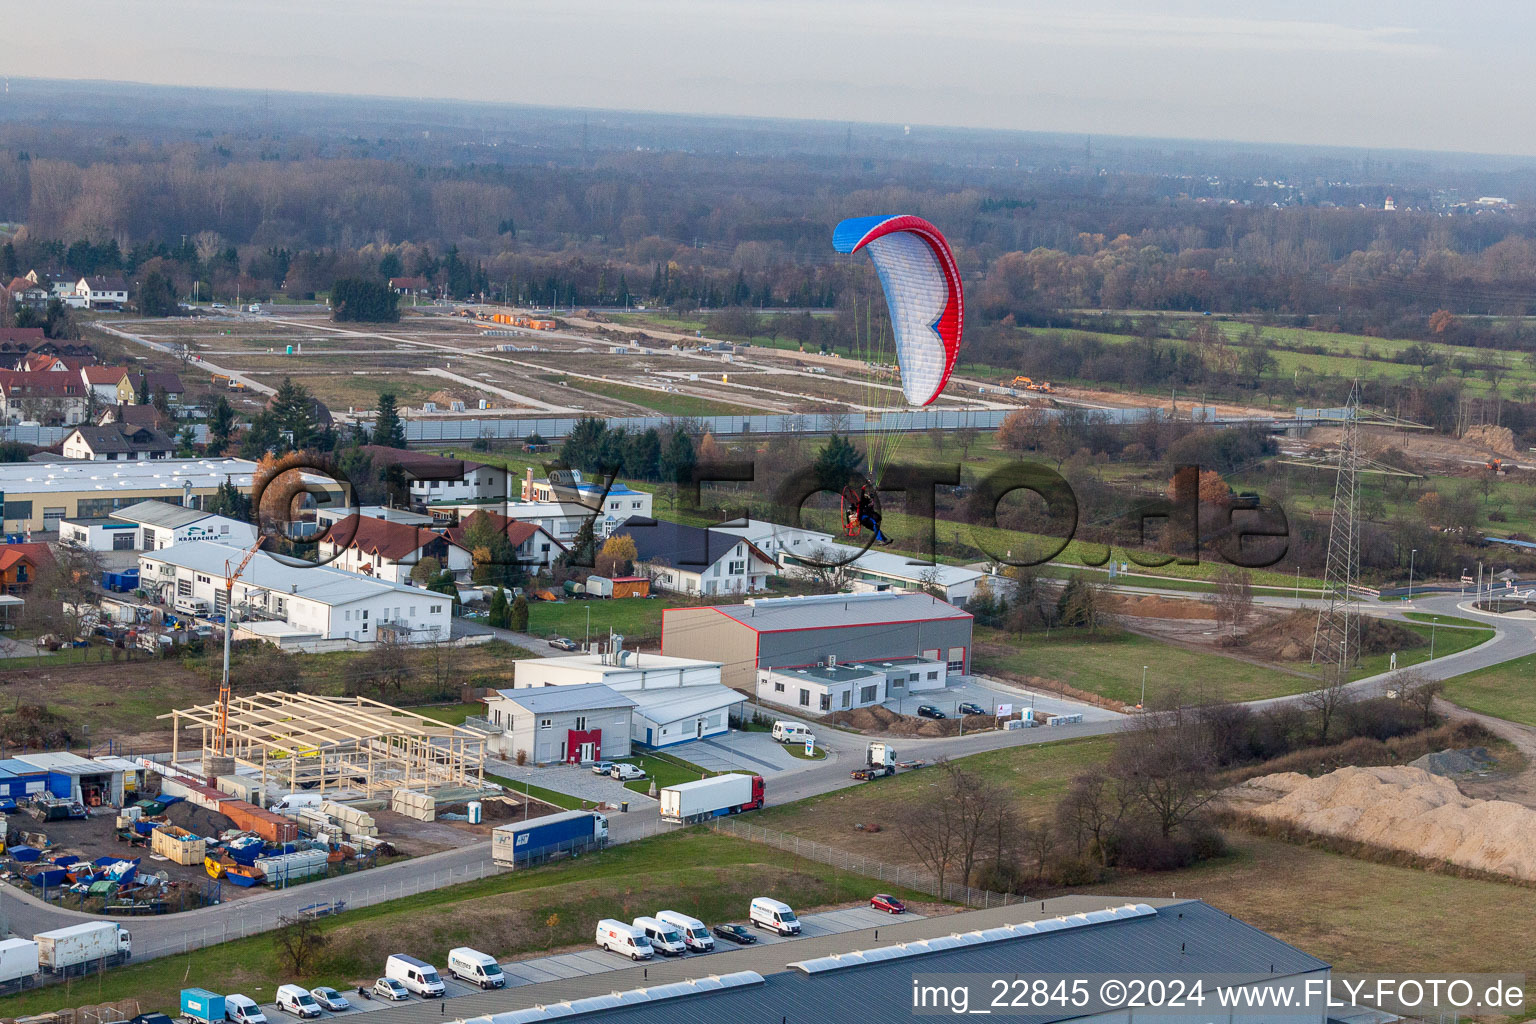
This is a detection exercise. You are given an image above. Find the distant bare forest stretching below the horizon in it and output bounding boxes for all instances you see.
[0,83,1536,340]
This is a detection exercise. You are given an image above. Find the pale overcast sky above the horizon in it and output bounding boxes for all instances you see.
[5,0,1536,154]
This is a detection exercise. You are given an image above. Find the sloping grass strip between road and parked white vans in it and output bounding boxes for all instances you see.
[0,829,923,1016]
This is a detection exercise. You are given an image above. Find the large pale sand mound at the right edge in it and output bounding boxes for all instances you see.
[1230,766,1536,881]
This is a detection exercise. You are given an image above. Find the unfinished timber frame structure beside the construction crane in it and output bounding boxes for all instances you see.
[160,692,485,797]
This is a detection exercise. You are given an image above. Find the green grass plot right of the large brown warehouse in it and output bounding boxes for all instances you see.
[974,626,1316,705]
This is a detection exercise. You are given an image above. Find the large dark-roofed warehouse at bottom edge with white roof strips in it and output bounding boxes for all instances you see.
[423,897,1333,1024]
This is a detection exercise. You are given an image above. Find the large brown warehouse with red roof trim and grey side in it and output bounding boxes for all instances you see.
[662,593,972,692]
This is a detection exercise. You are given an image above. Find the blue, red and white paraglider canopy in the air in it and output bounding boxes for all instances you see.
[833,215,965,405]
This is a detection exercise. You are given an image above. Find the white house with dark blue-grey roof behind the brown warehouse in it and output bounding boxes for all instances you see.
[613,519,776,596]
